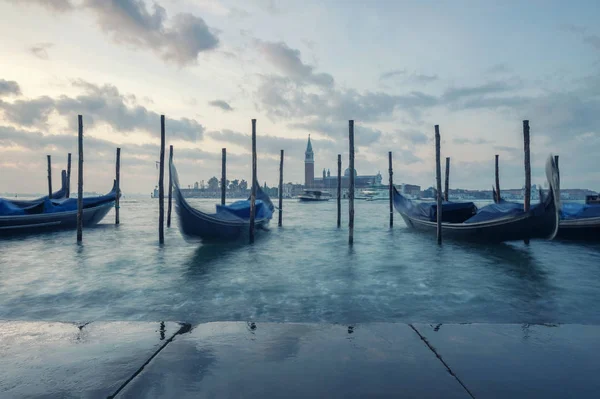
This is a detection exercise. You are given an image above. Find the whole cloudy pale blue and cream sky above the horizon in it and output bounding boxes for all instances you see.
[0,0,600,193]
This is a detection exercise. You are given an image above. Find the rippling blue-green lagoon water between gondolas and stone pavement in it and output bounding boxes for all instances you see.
[0,199,600,324]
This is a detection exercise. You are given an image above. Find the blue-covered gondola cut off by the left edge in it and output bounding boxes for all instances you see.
[0,182,117,236]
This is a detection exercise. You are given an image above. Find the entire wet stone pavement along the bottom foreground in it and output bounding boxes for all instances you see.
[0,321,600,398]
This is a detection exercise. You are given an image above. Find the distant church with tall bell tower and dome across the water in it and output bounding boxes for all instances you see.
[304,135,383,189]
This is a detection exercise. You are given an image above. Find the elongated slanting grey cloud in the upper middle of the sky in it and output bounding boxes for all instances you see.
[258,41,334,87]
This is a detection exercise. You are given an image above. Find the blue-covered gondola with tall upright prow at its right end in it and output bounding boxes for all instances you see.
[393,157,560,242]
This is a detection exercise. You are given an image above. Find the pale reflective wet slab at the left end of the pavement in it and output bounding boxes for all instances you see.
[0,321,182,399]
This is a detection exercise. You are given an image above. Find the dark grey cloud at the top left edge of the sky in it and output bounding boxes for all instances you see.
[10,0,219,66]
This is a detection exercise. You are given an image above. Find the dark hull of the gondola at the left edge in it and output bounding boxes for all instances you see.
[0,202,114,236]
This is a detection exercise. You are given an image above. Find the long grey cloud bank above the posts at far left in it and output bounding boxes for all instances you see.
[0,80,204,141]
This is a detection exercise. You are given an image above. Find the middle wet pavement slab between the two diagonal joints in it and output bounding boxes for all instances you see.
[117,322,469,398]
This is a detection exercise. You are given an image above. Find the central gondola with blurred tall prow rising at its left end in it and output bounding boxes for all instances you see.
[170,164,274,241]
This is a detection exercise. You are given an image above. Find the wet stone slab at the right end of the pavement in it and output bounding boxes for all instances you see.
[414,324,600,399]
